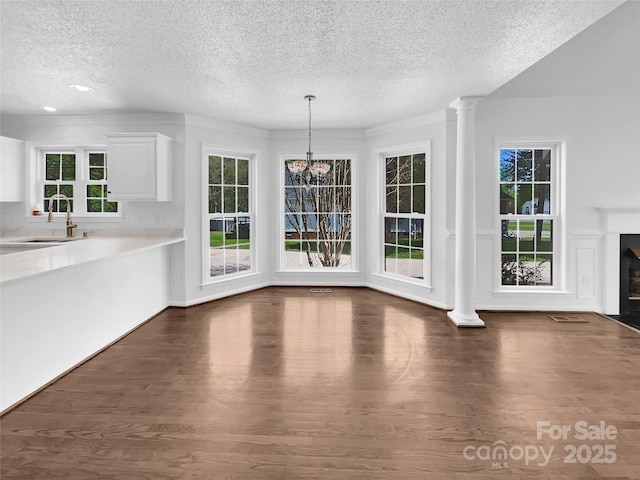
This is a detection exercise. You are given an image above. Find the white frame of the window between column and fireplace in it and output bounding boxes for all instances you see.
[493,137,568,294]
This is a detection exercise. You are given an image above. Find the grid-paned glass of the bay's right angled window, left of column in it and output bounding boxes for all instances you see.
[384,152,427,279]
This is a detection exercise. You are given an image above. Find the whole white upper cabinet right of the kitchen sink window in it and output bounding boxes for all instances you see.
[106,133,173,201]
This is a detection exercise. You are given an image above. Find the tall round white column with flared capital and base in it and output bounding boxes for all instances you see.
[447,97,484,327]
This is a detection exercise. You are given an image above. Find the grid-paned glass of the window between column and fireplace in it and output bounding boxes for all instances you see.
[499,147,557,286]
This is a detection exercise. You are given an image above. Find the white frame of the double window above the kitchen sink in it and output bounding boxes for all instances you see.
[27,145,122,222]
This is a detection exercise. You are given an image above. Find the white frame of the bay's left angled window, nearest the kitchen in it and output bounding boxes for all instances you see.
[200,143,258,288]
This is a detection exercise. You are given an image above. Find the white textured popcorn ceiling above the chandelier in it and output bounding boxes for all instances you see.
[0,0,622,129]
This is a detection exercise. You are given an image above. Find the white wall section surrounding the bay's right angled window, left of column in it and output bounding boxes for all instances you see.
[365,118,455,308]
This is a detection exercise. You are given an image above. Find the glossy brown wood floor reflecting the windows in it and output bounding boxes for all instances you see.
[1,287,640,480]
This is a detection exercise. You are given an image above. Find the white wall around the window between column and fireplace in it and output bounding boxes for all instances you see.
[476,96,640,312]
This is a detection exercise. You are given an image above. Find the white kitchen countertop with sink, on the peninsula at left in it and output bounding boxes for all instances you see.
[0,230,185,284]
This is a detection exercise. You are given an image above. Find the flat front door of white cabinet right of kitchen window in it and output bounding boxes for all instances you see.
[107,137,156,200]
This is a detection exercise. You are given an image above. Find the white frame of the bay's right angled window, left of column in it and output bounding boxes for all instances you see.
[375,140,433,288]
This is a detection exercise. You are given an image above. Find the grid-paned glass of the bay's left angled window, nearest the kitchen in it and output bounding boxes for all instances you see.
[207,155,252,278]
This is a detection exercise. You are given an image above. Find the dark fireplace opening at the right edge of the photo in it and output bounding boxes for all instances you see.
[620,234,640,322]
